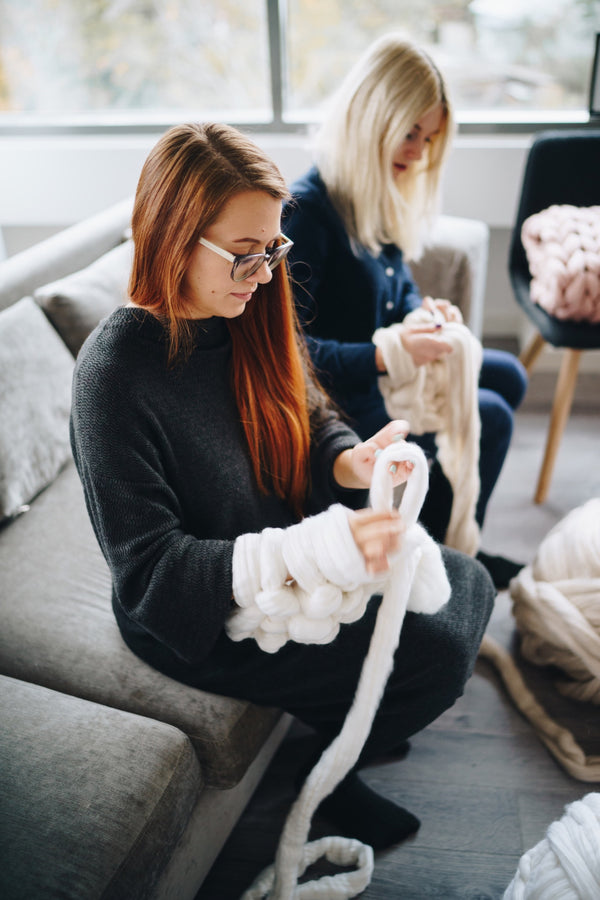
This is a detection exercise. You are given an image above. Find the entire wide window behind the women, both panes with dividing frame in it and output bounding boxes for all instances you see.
[0,0,600,128]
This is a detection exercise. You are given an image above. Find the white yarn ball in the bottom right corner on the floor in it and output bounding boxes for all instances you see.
[503,794,600,900]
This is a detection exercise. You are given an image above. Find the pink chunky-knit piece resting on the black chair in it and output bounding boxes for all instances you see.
[521,205,600,322]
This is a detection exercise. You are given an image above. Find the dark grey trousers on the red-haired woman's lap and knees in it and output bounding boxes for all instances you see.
[190,547,495,763]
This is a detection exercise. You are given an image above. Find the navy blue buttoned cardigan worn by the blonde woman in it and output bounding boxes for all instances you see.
[283,167,422,415]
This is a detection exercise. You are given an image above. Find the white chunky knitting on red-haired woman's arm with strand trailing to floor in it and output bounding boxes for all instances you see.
[226,442,450,900]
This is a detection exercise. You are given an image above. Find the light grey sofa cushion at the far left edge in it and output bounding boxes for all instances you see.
[0,297,73,521]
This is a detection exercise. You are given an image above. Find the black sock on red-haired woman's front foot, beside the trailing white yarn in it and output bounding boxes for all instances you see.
[318,772,421,850]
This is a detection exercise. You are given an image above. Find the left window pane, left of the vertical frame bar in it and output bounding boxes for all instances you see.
[0,0,271,118]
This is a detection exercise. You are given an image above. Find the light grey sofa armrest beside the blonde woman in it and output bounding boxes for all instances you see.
[411,216,490,339]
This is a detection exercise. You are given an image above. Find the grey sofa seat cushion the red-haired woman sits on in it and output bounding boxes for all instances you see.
[0,462,281,788]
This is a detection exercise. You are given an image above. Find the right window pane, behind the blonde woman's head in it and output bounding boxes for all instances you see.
[287,0,600,118]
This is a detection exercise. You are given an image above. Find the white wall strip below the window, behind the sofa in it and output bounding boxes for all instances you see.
[0,134,529,228]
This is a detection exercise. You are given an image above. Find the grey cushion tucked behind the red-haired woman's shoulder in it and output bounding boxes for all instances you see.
[33,240,133,356]
